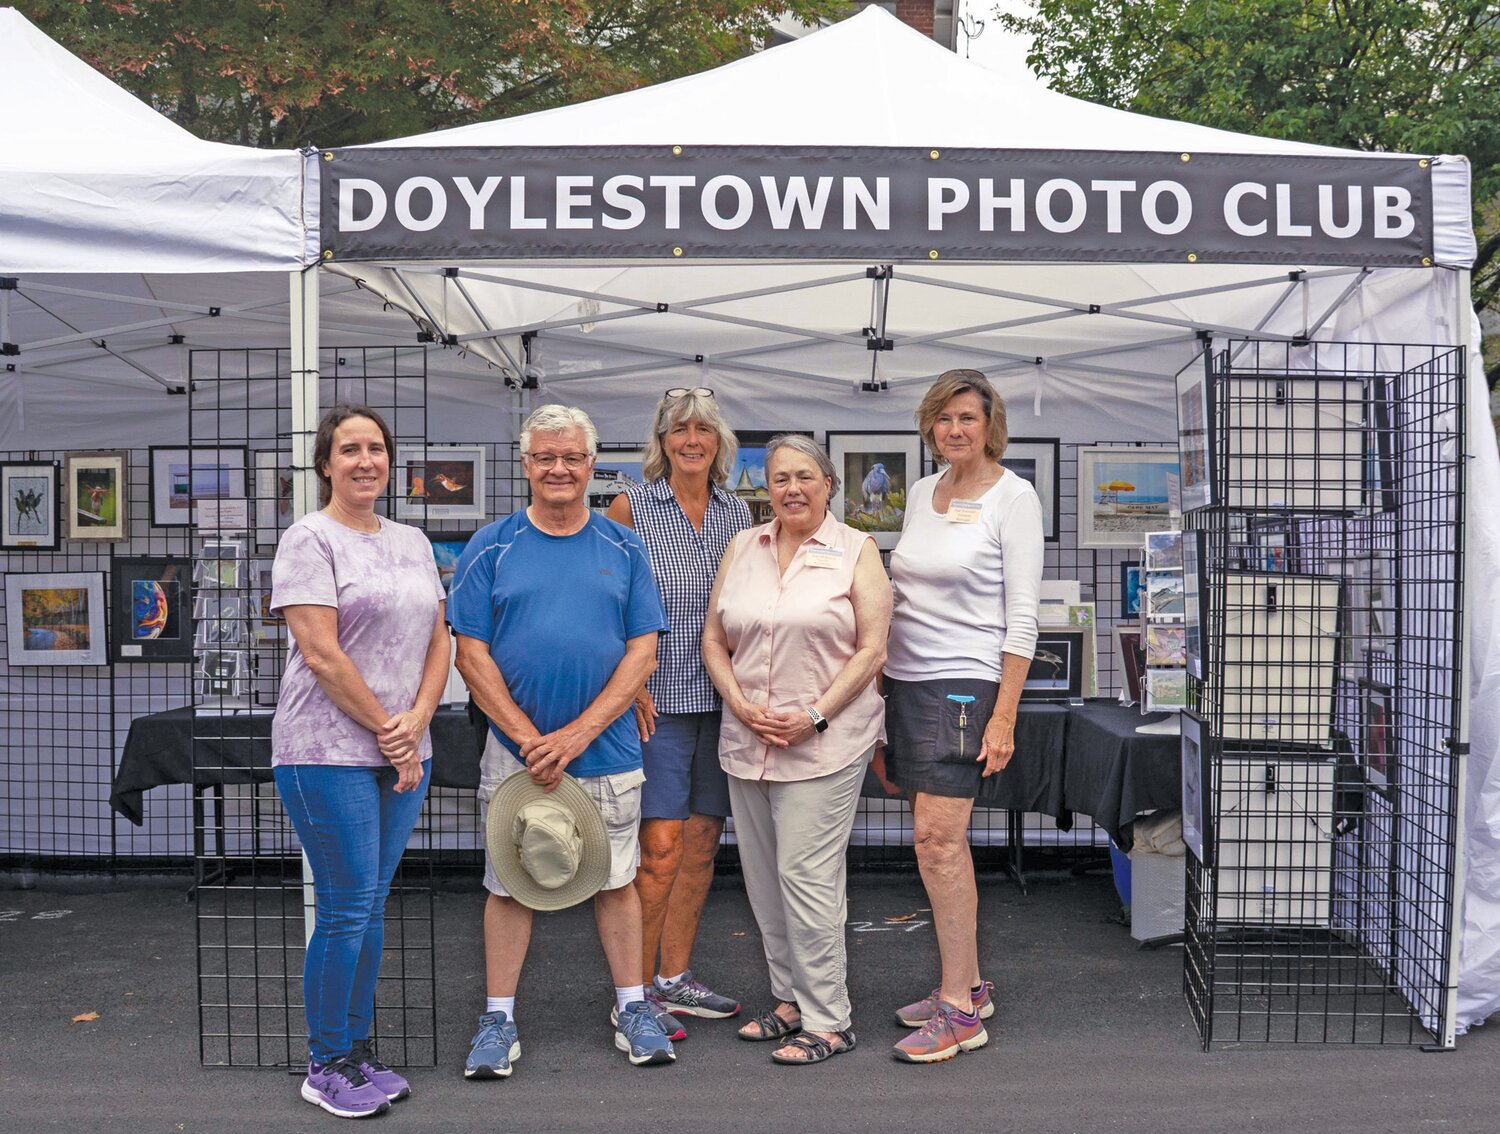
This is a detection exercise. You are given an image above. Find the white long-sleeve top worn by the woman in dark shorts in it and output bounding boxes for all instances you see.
[885,471,1043,681]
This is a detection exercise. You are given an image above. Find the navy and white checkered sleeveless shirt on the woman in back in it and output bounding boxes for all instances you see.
[626,480,750,713]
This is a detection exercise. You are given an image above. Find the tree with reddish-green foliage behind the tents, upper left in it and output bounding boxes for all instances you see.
[17,0,845,147]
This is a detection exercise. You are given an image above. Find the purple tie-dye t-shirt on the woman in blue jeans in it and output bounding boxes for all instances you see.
[272,512,443,768]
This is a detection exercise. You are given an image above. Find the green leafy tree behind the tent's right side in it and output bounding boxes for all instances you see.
[998,0,1500,386]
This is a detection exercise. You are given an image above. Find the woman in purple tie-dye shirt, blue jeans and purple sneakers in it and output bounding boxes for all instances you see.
[272,405,449,1118]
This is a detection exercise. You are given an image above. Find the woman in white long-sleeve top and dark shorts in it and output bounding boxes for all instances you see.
[885,371,1043,1064]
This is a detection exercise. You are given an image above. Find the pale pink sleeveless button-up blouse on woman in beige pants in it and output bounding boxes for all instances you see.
[719,513,885,780]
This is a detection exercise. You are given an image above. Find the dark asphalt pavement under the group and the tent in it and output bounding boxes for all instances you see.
[0,872,1500,1134]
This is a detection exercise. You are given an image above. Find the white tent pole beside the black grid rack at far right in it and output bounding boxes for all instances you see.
[1437,269,1493,1050]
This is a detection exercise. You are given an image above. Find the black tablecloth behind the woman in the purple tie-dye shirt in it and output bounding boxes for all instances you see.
[110,708,485,827]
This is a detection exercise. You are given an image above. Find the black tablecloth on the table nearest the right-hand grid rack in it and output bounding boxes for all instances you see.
[1062,701,1182,851]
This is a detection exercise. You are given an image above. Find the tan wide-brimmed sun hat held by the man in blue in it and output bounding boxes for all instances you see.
[485,773,609,909]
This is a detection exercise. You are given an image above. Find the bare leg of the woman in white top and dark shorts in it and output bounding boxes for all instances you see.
[912,792,980,1011]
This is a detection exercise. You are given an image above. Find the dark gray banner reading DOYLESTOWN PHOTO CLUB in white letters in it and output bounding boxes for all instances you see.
[321,146,1433,266]
